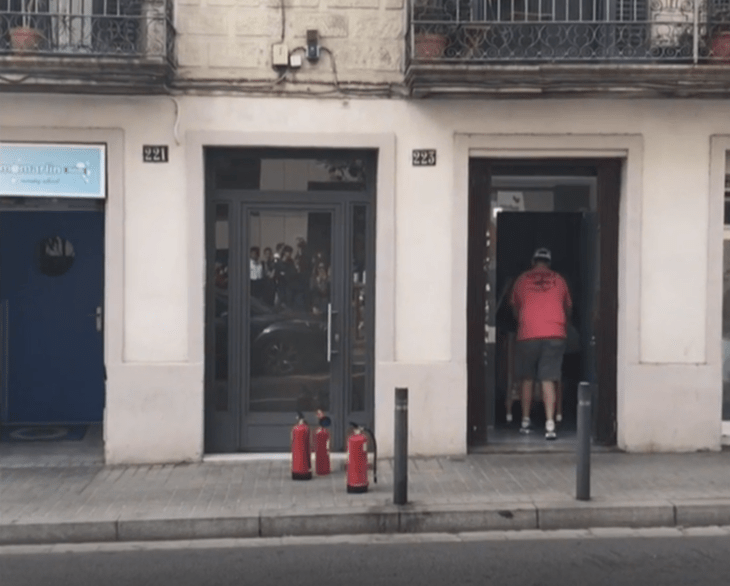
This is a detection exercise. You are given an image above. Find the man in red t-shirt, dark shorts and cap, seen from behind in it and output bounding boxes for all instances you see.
[510,248,573,439]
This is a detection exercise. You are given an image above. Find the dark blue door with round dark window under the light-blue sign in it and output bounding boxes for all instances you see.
[0,211,104,423]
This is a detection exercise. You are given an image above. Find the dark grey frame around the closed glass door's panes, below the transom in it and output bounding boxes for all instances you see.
[205,189,376,453]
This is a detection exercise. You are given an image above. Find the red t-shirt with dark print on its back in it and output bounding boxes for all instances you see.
[510,265,573,340]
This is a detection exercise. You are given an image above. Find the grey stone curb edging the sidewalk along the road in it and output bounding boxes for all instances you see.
[0,498,730,545]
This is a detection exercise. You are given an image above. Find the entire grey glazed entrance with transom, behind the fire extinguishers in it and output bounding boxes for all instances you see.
[205,148,376,453]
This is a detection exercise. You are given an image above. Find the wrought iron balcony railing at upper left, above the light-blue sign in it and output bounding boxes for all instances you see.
[0,0,175,64]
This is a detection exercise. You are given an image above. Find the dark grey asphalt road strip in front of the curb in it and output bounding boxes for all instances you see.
[0,535,730,586]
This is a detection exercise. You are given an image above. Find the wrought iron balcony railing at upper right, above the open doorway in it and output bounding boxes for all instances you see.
[408,0,730,63]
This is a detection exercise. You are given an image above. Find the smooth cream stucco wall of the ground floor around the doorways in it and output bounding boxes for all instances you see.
[0,96,730,462]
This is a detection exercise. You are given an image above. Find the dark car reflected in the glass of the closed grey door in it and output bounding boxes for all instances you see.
[216,296,327,376]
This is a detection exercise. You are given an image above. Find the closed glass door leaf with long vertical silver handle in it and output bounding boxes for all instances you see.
[240,205,345,450]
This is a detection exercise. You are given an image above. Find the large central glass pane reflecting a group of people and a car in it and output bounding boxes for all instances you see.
[247,205,338,416]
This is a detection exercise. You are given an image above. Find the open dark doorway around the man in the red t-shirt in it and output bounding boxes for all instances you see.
[467,159,620,450]
